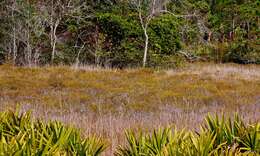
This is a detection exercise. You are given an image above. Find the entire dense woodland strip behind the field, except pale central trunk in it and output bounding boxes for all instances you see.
[0,0,260,67]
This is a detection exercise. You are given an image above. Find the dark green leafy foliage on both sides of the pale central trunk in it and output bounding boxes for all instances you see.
[97,13,181,67]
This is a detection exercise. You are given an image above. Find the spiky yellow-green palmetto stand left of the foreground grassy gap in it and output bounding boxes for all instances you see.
[0,112,106,156]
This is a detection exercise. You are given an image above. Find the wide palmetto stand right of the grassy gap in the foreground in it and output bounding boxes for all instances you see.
[115,114,260,156]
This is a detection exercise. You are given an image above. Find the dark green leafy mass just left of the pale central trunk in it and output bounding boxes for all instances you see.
[97,13,142,67]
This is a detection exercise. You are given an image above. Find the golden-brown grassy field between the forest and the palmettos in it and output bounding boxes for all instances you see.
[0,63,260,155]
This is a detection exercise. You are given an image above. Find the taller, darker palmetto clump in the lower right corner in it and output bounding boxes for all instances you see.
[204,114,260,152]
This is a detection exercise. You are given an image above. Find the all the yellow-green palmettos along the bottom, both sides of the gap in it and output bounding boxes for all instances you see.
[0,112,260,156]
